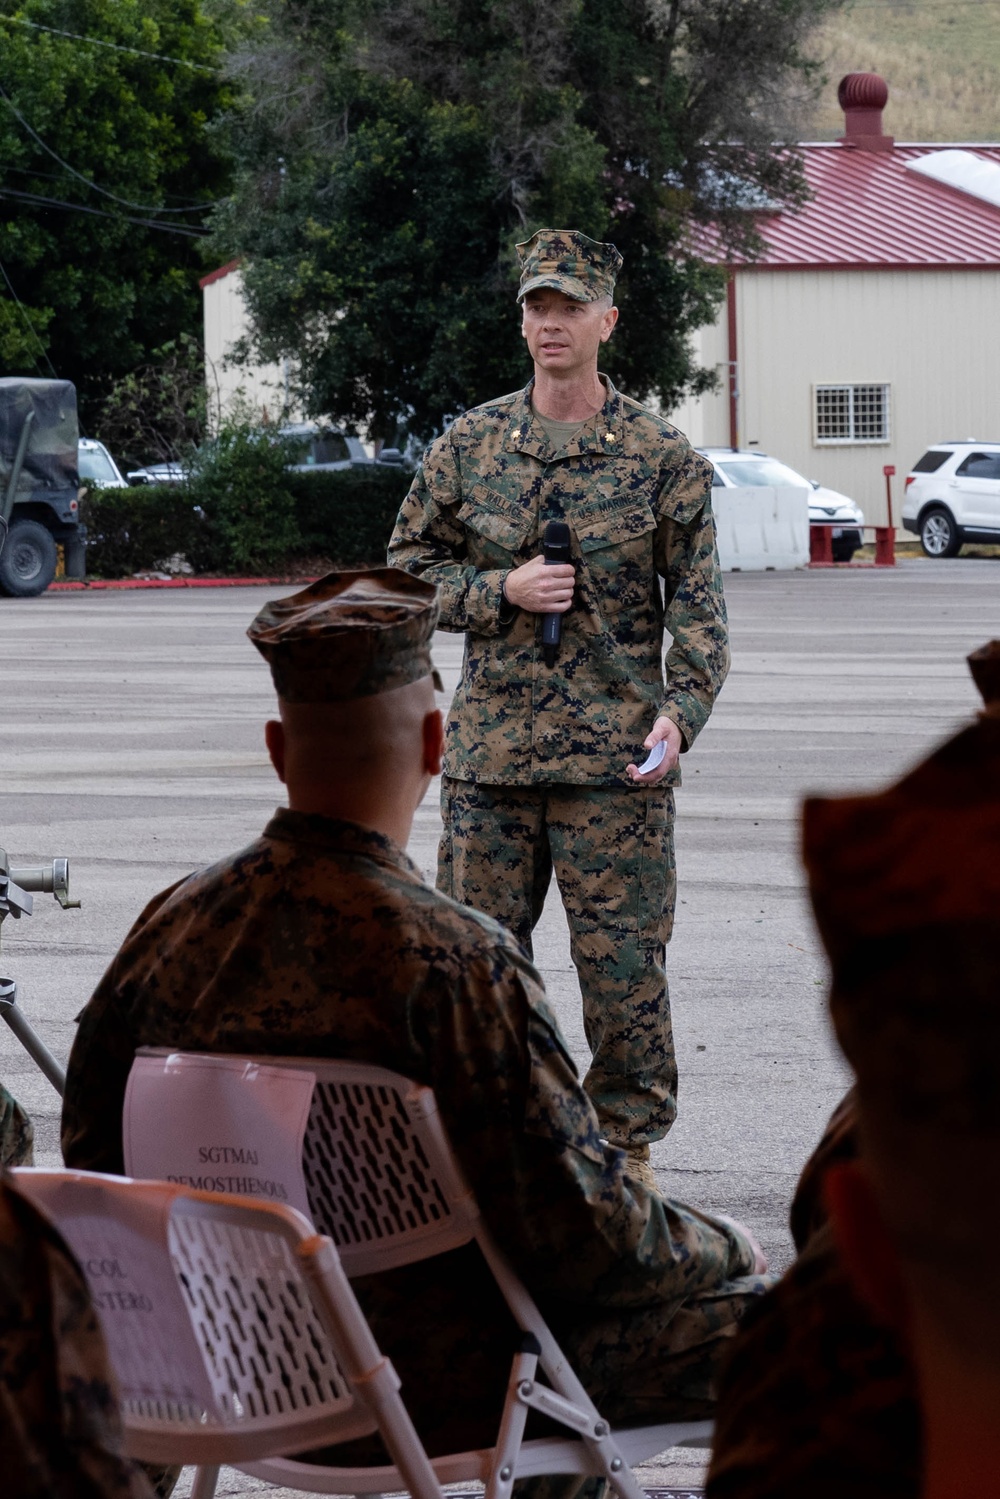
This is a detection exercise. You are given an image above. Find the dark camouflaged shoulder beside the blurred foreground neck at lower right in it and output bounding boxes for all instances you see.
[706,1093,922,1499]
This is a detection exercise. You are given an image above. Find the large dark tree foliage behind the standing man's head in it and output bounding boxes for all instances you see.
[216,0,843,438]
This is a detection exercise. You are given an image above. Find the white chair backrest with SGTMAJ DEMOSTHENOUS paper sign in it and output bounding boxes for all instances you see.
[123,1048,478,1276]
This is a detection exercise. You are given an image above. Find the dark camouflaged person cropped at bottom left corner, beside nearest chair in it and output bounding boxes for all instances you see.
[0,1175,150,1499]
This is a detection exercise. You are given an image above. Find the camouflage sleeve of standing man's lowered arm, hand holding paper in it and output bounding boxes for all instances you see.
[655,448,730,750]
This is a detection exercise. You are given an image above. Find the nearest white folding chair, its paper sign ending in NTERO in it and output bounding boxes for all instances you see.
[10,1168,441,1499]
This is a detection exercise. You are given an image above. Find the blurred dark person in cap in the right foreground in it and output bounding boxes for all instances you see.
[708,642,1000,1499]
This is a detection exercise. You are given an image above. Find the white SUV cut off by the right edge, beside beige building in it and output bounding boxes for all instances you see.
[903,438,1000,558]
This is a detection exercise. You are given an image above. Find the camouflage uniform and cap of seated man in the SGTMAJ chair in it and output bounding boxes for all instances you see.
[63,570,769,1487]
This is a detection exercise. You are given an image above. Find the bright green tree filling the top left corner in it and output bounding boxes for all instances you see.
[0,0,241,421]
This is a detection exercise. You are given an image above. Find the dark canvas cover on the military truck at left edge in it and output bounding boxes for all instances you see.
[0,376,79,501]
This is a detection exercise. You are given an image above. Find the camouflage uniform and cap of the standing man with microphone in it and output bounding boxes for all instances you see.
[388,231,729,1169]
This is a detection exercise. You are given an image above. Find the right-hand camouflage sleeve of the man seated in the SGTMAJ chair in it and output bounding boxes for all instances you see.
[417,949,753,1307]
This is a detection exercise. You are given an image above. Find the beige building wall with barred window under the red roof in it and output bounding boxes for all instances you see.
[728,267,1000,525]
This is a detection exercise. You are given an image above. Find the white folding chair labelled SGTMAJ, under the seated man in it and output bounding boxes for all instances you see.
[123,1048,712,1499]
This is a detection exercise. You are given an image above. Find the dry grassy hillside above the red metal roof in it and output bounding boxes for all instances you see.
[802,0,1000,141]
